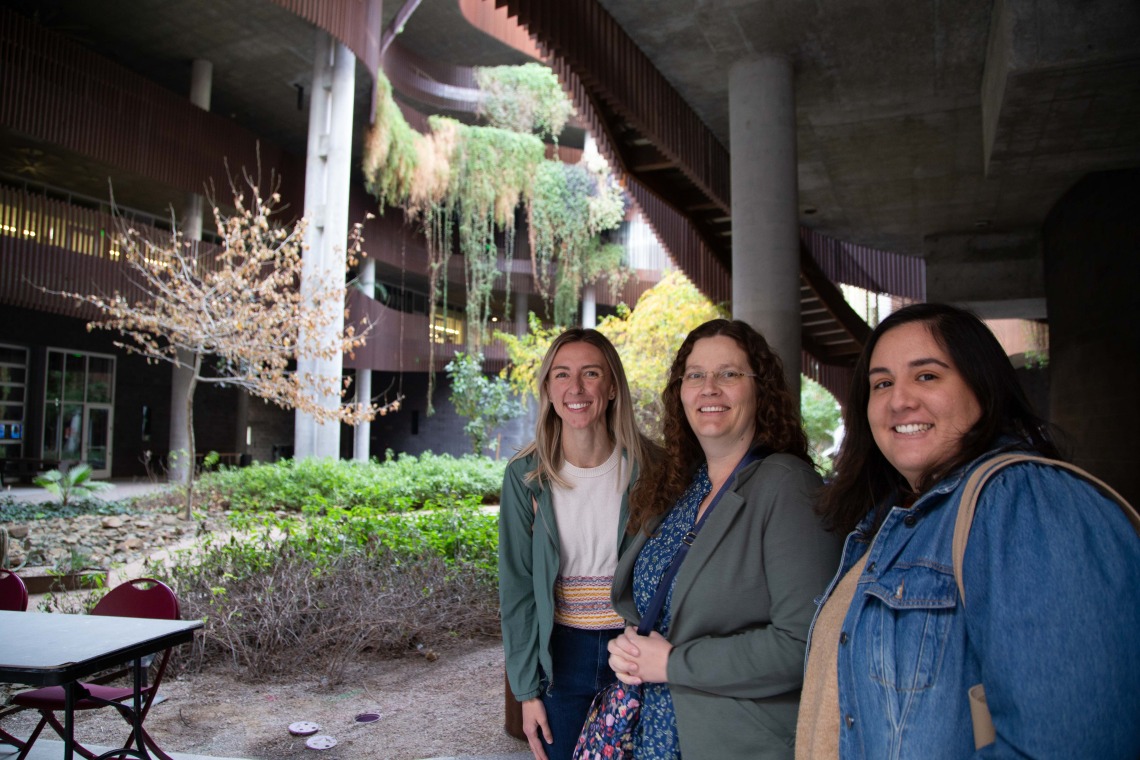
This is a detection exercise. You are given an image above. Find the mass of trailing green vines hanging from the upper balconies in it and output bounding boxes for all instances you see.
[363,64,626,410]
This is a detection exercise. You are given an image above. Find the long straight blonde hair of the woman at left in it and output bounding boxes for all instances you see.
[512,327,652,488]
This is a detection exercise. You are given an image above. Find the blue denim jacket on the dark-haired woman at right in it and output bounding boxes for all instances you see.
[808,455,1140,760]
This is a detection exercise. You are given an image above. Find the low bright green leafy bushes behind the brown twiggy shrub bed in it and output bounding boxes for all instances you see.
[198,452,506,512]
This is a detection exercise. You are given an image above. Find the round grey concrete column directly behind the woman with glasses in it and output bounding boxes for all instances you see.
[728,56,801,399]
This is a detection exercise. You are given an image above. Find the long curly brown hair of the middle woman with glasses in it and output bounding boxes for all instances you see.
[628,319,812,533]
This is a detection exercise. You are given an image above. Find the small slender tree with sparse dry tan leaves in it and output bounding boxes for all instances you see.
[60,174,387,520]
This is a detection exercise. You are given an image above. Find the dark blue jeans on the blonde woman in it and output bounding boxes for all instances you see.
[542,624,621,760]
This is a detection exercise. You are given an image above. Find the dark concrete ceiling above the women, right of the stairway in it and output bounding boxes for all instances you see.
[600,0,1140,255]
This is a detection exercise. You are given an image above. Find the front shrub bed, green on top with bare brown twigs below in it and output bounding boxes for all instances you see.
[148,497,498,680]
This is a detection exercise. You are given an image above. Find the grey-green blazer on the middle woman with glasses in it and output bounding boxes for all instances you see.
[612,453,841,760]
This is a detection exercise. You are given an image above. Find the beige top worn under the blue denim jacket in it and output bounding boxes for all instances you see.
[796,554,866,760]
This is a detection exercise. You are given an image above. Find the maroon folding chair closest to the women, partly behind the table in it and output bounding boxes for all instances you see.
[11,578,180,760]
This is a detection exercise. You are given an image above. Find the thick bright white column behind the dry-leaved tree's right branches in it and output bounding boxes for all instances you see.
[293,32,356,459]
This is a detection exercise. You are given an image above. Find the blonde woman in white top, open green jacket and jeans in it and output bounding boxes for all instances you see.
[499,328,652,760]
